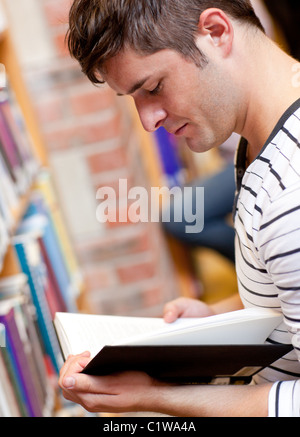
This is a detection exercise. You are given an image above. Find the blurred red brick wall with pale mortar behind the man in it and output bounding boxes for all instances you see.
[27,0,178,315]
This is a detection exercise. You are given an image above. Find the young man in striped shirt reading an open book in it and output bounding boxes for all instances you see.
[60,0,300,416]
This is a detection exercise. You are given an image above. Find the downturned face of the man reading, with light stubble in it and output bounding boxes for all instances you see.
[103,48,236,152]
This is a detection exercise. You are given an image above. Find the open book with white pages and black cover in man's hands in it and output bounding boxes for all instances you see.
[54,308,292,383]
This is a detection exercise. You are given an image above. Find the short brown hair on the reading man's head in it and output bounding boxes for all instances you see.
[66,0,264,83]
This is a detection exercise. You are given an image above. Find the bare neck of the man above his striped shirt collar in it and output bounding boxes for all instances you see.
[241,40,300,163]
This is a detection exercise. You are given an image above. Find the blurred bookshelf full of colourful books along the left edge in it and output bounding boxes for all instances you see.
[0,3,84,417]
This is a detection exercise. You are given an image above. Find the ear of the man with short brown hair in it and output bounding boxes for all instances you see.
[198,8,234,56]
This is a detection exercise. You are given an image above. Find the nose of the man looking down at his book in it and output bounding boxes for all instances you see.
[135,100,167,132]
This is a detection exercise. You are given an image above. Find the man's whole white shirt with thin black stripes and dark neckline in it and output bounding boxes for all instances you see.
[234,99,300,417]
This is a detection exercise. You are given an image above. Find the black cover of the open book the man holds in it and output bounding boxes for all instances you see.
[83,344,292,383]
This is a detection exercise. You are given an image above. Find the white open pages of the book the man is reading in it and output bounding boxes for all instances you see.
[54,308,282,357]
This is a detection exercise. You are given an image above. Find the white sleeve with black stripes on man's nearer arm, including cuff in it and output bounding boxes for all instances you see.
[258,183,300,417]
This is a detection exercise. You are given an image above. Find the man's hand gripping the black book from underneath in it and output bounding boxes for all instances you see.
[59,352,159,413]
